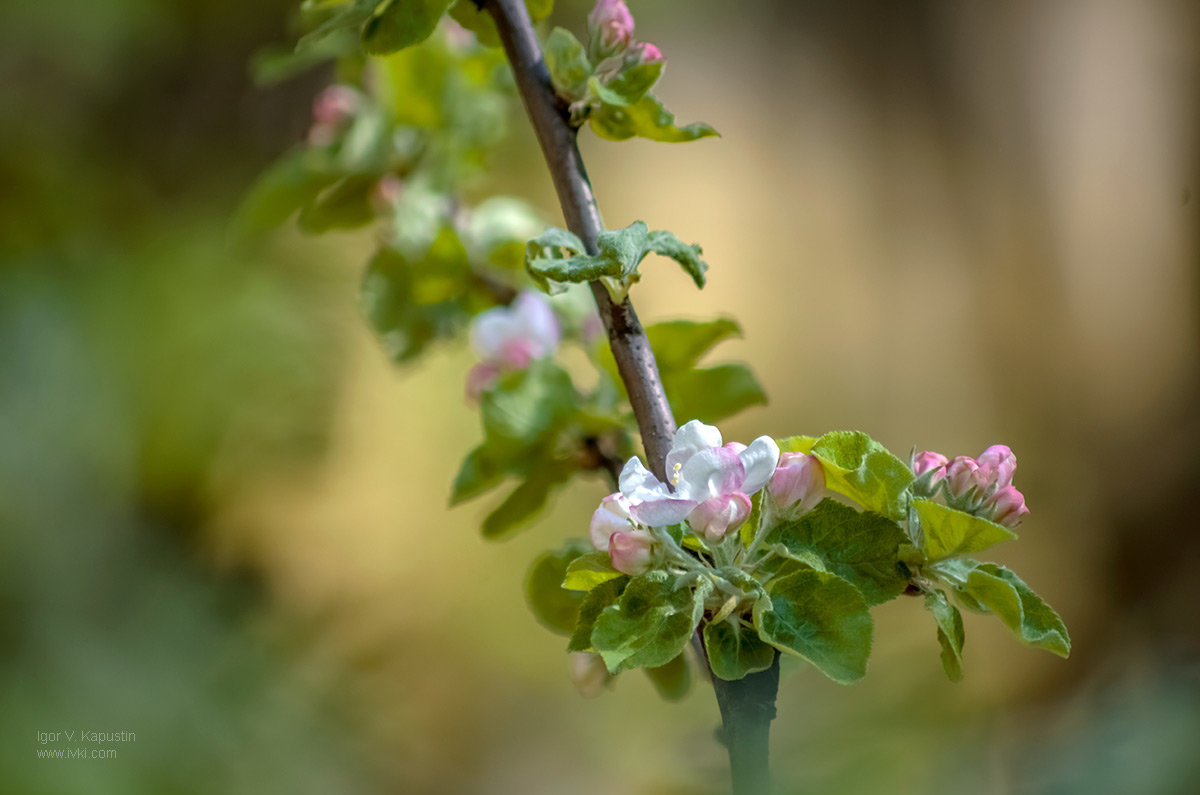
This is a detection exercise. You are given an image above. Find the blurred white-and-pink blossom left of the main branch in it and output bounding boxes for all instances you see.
[467,291,562,400]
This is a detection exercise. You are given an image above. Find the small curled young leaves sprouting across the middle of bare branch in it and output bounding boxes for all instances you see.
[526,221,708,300]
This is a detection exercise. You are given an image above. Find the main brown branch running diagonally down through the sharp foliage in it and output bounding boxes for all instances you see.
[476,0,779,795]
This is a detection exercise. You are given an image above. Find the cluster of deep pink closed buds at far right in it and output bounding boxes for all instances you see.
[912,444,1030,527]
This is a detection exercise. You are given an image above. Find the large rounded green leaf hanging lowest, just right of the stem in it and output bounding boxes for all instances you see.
[754,569,874,683]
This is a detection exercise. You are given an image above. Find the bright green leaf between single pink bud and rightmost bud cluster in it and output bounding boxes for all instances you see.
[812,431,913,521]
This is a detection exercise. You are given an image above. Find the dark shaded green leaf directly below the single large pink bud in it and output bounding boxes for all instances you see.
[763,498,908,605]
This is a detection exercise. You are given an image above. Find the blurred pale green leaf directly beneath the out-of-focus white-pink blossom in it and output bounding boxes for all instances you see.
[480,359,577,450]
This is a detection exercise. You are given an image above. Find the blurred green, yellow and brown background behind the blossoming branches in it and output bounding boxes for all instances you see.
[0,0,1200,795]
